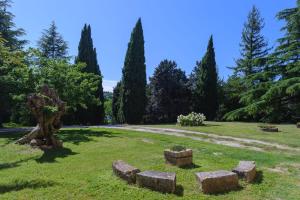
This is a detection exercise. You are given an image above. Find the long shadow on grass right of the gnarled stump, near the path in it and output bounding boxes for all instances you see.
[58,129,118,145]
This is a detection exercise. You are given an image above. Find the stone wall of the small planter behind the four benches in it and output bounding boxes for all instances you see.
[164,149,193,167]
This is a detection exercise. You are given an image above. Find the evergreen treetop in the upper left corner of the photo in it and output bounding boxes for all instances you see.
[0,0,27,51]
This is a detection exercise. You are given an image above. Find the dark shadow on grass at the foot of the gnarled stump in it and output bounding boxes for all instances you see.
[36,148,78,163]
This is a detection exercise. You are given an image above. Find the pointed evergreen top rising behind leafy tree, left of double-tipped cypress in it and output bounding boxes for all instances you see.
[38,22,68,59]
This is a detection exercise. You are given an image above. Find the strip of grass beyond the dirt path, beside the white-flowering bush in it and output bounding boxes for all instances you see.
[146,122,300,147]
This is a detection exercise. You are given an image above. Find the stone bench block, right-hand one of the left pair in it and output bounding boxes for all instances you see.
[136,171,176,193]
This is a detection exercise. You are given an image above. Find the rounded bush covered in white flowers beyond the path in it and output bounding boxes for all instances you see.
[177,112,206,126]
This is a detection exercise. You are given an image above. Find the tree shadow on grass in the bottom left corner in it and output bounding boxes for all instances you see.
[0,180,55,194]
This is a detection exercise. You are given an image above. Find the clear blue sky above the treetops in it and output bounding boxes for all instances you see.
[11,0,296,90]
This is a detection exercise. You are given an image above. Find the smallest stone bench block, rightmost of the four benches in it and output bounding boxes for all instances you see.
[232,161,256,182]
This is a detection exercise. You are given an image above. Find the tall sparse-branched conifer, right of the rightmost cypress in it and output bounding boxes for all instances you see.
[224,6,274,121]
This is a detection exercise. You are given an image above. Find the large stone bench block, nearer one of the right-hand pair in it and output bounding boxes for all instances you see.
[196,170,239,194]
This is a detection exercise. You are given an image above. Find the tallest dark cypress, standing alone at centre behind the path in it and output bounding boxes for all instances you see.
[121,19,146,124]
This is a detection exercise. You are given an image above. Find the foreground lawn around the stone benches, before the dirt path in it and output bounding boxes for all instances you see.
[0,125,300,200]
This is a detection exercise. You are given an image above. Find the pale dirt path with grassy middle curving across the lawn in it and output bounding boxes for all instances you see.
[109,126,300,152]
